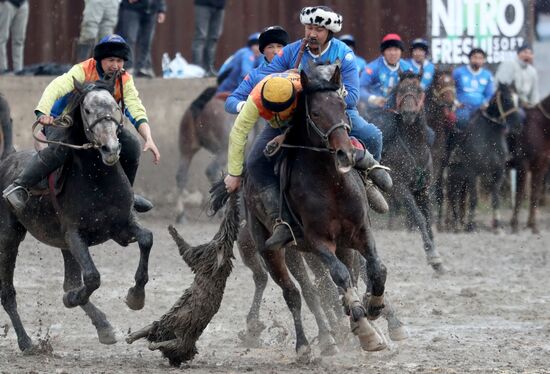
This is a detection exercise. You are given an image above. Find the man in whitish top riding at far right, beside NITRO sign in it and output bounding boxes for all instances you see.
[495,44,540,123]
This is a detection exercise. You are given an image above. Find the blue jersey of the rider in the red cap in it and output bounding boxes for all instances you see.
[361,56,413,105]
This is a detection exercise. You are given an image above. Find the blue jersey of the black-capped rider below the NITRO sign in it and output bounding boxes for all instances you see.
[453,65,494,119]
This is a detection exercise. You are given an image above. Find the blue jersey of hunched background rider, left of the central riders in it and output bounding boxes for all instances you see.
[218,47,260,92]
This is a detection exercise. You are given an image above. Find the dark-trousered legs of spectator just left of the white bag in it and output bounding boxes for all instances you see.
[117,0,166,78]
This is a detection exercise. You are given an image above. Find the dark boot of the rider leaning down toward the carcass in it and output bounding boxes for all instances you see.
[259,186,294,251]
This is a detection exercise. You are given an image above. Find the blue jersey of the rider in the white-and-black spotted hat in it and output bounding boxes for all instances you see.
[261,38,359,109]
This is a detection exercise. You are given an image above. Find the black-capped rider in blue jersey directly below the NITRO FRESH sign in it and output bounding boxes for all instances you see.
[453,48,495,130]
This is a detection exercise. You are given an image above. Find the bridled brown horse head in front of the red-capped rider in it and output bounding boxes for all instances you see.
[395,71,425,126]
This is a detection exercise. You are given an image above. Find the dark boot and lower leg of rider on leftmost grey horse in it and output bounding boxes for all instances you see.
[2,147,64,212]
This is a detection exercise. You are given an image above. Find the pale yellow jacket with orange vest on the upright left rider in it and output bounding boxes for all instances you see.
[35,58,149,128]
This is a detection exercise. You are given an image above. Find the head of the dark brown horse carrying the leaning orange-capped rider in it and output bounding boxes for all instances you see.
[300,63,355,173]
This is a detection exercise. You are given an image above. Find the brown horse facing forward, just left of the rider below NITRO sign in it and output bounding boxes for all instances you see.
[426,70,456,230]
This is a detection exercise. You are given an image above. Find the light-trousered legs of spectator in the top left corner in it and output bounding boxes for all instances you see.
[0,0,29,74]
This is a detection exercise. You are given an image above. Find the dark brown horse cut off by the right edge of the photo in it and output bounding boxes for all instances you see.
[511,96,550,234]
